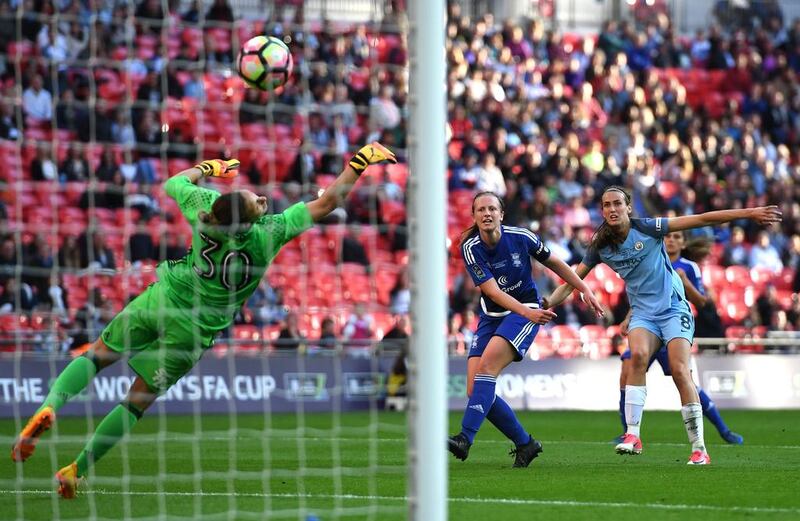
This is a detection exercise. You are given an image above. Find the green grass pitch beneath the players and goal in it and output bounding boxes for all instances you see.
[0,411,800,521]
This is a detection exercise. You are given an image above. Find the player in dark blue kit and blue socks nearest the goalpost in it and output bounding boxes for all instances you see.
[447,192,603,467]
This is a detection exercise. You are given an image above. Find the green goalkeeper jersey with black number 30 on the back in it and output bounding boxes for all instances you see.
[157,176,313,330]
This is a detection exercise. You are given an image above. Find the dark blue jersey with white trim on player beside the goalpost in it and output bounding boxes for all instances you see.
[461,226,550,317]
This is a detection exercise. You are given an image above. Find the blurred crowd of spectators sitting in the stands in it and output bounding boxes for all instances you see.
[0,0,800,352]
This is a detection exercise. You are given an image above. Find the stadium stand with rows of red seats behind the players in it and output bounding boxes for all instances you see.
[0,2,800,357]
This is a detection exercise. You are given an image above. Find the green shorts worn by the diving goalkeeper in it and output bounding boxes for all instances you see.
[101,282,217,394]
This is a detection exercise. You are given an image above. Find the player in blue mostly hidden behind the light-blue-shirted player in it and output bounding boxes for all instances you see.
[616,231,744,445]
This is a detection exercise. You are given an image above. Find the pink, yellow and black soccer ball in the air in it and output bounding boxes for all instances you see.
[236,36,292,91]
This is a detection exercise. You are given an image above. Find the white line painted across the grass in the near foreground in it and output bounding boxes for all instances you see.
[6,489,800,514]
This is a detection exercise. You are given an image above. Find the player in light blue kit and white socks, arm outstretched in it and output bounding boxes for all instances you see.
[547,186,781,465]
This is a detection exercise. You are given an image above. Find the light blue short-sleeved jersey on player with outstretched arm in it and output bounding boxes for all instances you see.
[583,217,686,316]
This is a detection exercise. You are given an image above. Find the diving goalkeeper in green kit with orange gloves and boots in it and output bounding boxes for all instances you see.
[11,142,397,498]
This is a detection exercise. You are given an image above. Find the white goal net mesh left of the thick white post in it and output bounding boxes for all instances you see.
[0,0,408,520]
